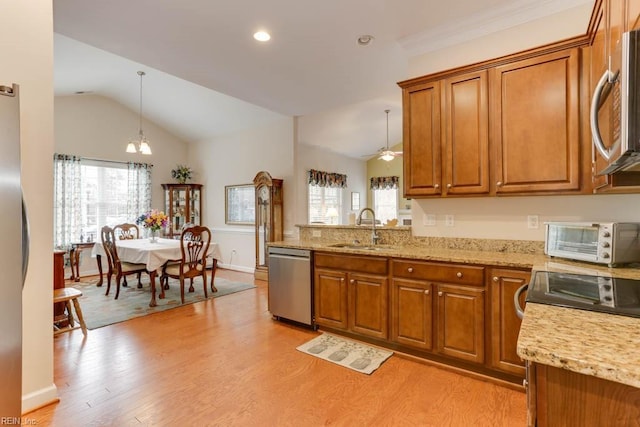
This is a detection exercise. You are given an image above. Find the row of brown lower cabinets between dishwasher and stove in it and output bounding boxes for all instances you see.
[314,252,530,383]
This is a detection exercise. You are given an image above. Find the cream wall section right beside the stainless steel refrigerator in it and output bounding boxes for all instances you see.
[0,0,57,412]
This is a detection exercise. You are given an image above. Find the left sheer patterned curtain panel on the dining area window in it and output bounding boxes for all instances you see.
[53,154,82,250]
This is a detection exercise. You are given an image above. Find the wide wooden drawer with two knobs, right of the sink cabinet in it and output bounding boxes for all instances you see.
[391,259,484,286]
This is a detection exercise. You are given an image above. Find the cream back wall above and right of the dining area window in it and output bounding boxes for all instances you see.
[54,95,189,211]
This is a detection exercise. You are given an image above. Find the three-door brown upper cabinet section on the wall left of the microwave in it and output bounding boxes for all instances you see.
[399,42,586,197]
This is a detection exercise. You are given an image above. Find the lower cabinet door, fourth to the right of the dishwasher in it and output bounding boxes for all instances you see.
[436,284,485,363]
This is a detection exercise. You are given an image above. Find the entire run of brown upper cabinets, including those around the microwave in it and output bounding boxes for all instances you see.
[398,0,640,198]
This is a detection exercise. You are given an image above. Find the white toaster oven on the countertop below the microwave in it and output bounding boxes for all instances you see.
[544,222,640,267]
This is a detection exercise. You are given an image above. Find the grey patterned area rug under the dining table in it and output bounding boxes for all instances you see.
[67,274,255,329]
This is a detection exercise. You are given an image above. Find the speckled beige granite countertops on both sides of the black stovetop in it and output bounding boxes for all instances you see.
[270,241,640,388]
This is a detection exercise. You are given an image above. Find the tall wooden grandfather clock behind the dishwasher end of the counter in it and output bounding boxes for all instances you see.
[253,171,283,280]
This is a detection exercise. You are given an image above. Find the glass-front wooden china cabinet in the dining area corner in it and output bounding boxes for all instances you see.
[162,184,202,238]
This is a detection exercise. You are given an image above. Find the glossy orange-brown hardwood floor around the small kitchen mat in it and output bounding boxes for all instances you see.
[24,270,526,427]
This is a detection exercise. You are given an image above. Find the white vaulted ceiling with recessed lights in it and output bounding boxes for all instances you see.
[53,0,593,157]
